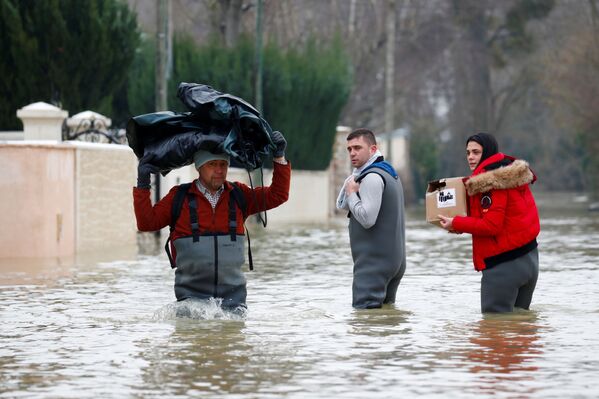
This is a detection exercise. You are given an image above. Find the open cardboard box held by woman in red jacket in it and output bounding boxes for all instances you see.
[426,177,468,227]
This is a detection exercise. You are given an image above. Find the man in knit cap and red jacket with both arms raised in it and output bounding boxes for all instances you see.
[133,131,291,309]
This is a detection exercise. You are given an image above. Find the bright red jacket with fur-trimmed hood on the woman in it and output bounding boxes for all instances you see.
[453,153,540,271]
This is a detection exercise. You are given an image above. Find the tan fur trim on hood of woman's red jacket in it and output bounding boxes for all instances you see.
[464,159,535,195]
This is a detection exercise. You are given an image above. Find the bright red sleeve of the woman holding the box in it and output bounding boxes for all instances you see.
[453,190,508,236]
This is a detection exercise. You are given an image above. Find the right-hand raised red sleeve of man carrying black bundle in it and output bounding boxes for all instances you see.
[238,162,291,215]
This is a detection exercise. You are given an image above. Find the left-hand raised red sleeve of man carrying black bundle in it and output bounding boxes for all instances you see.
[133,187,176,231]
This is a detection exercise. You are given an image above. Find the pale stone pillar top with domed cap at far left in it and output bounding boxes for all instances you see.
[17,102,69,141]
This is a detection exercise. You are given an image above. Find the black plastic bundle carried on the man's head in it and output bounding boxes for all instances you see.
[127,83,274,175]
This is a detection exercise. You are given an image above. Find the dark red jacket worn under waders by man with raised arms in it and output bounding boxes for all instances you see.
[133,162,291,241]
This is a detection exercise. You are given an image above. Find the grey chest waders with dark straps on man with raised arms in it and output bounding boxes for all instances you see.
[166,185,251,308]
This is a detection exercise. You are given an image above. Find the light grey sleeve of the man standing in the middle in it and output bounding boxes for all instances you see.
[347,173,385,229]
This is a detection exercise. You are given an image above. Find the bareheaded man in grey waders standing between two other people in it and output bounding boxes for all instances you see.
[337,129,406,309]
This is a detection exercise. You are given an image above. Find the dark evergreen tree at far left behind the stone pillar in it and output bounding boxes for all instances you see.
[0,0,139,129]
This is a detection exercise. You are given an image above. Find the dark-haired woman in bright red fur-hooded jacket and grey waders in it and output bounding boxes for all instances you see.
[439,133,540,312]
